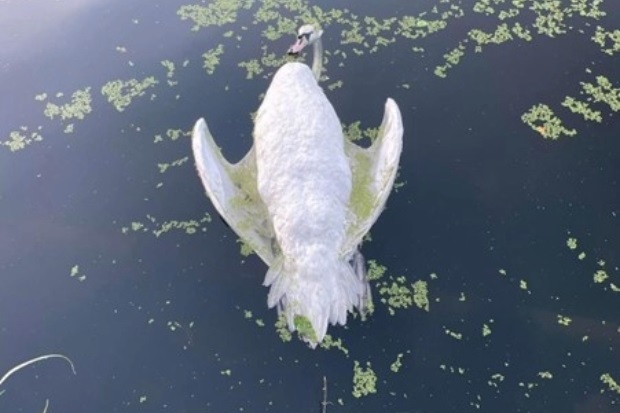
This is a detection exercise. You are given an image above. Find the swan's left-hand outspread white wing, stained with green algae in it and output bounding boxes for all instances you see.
[192,119,275,266]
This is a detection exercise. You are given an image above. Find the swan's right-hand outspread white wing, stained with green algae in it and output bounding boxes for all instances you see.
[341,99,403,256]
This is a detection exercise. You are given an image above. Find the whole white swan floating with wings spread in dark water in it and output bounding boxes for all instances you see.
[192,24,403,348]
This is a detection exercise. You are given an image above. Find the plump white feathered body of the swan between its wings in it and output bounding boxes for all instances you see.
[254,63,351,257]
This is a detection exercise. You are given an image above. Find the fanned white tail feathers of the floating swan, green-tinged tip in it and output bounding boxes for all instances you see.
[264,251,370,347]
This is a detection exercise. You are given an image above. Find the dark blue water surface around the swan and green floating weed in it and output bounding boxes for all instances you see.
[0,0,620,413]
